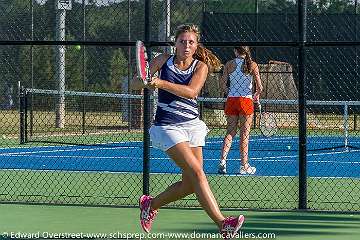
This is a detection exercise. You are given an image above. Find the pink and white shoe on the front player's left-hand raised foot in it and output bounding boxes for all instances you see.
[139,195,158,233]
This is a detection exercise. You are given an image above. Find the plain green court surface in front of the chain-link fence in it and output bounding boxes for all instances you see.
[0,204,360,240]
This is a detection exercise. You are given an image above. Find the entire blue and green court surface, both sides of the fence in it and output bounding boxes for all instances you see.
[0,127,360,240]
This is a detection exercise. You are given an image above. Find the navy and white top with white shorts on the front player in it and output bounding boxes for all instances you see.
[150,56,208,151]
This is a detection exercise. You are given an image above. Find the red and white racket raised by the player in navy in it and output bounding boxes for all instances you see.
[136,41,150,85]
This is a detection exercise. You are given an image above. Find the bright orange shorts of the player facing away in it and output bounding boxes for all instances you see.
[225,97,254,116]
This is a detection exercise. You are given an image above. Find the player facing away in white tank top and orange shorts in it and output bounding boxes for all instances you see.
[218,46,262,174]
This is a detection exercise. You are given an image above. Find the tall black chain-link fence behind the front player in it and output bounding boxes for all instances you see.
[0,0,360,211]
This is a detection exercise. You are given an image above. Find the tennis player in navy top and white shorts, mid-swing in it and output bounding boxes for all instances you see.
[134,25,244,239]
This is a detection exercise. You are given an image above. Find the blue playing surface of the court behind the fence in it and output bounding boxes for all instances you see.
[0,136,360,178]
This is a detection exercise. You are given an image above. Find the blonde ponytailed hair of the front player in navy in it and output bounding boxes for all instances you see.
[175,24,223,72]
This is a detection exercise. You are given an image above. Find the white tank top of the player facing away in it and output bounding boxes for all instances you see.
[228,58,253,98]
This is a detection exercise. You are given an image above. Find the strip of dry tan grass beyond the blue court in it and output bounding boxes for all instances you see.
[0,110,360,135]
